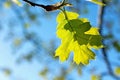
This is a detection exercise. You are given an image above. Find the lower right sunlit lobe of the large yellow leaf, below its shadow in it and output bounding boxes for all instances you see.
[71,41,95,65]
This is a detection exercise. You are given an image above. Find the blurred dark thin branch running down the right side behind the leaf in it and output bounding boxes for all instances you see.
[98,0,120,80]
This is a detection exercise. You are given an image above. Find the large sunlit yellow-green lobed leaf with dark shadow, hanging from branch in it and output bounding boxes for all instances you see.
[55,12,103,65]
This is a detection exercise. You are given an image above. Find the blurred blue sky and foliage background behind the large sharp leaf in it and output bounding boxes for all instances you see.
[0,0,120,80]
